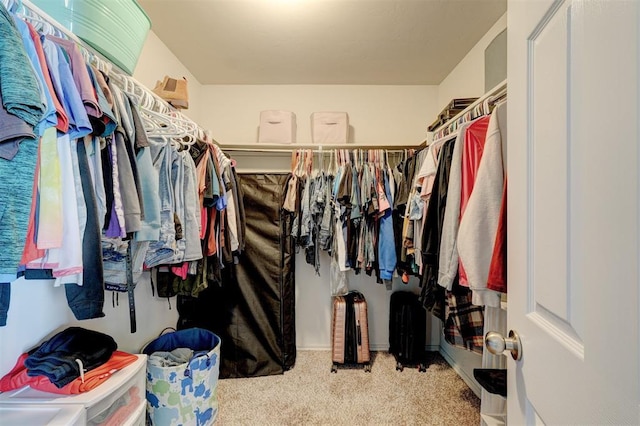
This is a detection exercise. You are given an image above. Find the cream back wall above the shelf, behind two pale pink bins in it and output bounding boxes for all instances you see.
[200,85,437,146]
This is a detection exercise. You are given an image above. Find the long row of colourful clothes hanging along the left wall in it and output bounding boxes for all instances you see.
[0,6,245,332]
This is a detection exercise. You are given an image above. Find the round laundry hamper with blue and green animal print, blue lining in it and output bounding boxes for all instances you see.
[142,328,220,426]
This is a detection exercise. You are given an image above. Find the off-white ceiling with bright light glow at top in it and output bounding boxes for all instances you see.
[138,0,507,85]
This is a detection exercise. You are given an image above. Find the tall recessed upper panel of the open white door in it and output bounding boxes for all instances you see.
[527,0,570,321]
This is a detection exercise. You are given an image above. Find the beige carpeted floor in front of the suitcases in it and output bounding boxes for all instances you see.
[217,351,480,426]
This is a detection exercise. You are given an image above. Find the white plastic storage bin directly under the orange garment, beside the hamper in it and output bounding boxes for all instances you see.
[0,355,147,425]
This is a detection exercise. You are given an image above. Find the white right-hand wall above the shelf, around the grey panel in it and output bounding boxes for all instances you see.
[438,13,507,113]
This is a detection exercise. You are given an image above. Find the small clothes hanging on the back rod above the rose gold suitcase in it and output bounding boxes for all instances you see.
[290,150,397,289]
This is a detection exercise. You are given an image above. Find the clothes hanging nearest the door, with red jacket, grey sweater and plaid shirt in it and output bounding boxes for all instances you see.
[422,95,506,353]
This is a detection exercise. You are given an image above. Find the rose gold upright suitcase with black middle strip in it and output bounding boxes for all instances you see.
[331,291,371,373]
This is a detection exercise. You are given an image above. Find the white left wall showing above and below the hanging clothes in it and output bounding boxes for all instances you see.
[0,32,192,375]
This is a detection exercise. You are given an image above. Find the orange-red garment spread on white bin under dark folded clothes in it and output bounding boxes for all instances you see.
[0,351,138,395]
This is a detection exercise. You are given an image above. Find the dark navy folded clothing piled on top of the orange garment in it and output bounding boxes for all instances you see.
[24,327,118,388]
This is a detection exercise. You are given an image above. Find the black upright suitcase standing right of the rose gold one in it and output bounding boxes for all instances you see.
[389,291,427,372]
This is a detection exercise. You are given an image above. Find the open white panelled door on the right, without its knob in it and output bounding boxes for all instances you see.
[507,0,640,425]
